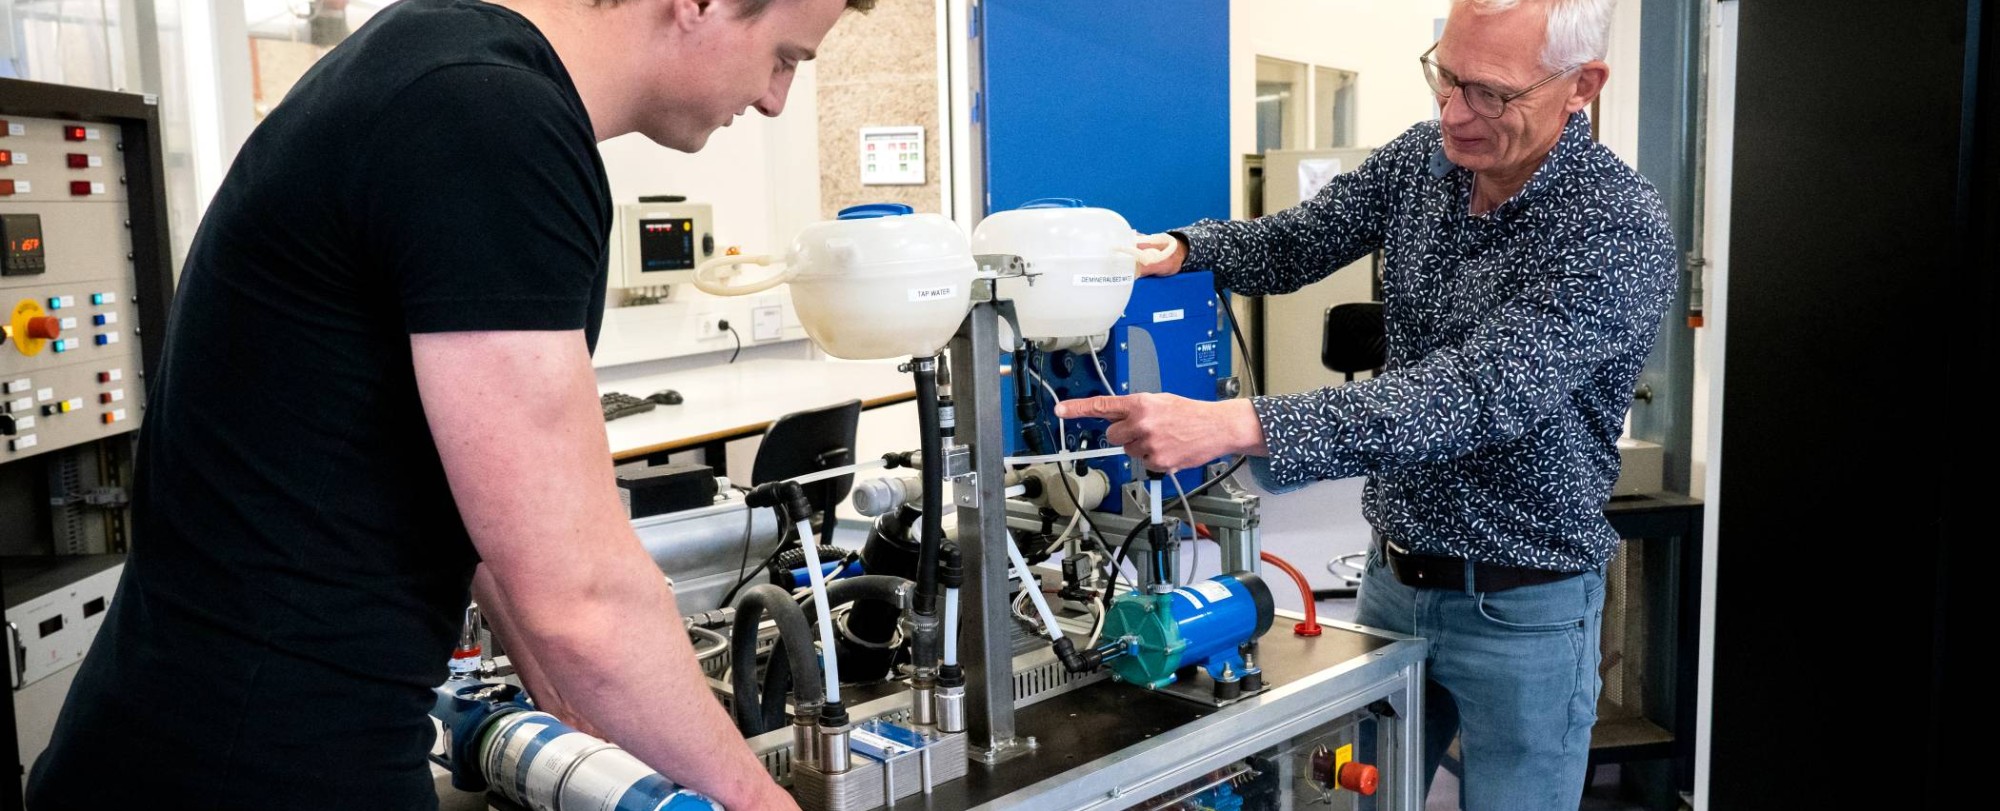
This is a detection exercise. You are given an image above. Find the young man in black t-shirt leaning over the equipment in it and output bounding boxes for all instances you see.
[28,0,870,811]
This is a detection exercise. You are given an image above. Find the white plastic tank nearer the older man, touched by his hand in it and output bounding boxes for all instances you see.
[972,198,1138,340]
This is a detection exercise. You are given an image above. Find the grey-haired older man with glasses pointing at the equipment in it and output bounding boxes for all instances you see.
[1058,0,1676,811]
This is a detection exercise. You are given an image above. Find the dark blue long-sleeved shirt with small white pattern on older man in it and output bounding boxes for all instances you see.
[1176,114,1676,571]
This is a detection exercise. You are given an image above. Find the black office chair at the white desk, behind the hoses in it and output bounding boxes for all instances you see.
[750,400,862,545]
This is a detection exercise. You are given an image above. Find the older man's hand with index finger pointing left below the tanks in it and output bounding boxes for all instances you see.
[1056,393,1270,473]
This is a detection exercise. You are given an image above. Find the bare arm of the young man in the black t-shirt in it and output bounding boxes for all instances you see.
[410,330,796,809]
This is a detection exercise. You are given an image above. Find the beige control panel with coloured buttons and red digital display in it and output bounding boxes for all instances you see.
[0,116,144,463]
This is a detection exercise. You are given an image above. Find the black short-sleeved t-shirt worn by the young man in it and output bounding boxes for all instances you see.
[30,0,612,811]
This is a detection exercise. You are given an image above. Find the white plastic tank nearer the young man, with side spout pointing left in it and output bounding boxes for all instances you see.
[694,204,978,360]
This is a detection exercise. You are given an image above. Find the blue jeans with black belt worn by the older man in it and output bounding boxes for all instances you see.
[1354,549,1604,811]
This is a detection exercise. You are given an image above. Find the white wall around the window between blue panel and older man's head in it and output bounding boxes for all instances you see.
[1230,0,1452,218]
